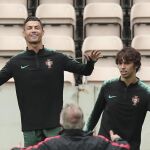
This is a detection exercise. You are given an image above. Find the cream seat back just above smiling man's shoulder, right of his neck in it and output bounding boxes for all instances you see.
[43,36,75,58]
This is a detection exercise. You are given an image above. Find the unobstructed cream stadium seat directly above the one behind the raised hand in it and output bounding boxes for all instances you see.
[83,3,123,37]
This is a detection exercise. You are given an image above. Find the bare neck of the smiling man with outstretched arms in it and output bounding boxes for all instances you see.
[27,43,43,53]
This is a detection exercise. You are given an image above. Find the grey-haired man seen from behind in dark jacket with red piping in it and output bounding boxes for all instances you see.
[12,104,130,150]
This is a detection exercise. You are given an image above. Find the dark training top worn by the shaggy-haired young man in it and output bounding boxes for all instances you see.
[87,79,150,150]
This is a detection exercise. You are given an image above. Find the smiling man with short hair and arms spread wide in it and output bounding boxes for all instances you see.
[0,16,100,146]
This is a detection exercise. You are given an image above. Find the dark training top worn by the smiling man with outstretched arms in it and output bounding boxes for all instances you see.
[0,48,94,131]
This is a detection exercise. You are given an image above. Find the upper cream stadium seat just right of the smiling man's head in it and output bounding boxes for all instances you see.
[36,4,76,38]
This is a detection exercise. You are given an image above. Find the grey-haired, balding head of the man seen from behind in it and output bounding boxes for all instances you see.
[60,104,84,129]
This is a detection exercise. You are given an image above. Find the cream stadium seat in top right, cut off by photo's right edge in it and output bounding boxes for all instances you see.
[130,2,150,38]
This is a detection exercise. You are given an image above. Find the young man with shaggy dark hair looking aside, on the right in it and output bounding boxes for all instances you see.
[86,47,150,150]
